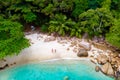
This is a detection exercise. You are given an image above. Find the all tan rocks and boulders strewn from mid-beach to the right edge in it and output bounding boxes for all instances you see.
[41,34,120,77]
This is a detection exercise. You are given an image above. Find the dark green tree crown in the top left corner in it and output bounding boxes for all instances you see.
[1,0,37,22]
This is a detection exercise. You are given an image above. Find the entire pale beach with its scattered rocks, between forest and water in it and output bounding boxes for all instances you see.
[0,33,119,79]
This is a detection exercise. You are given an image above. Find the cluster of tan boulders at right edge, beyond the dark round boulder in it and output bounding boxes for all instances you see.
[91,43,120,78]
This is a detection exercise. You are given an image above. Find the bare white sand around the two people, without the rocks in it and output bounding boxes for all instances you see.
[6,33,79,65]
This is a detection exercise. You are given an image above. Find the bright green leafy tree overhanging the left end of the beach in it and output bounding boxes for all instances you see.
[0,19,29,58]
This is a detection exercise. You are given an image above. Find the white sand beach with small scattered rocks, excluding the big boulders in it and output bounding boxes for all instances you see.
[5,33,110,65]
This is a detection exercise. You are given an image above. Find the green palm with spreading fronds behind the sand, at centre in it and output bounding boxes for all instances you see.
[48,14,81,37]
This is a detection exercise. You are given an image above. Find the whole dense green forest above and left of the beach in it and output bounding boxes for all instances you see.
[0,0,120,58]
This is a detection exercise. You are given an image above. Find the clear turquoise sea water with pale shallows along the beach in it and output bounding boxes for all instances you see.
[0,60,114,80]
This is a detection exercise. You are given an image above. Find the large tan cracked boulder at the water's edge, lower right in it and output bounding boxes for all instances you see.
[101,62,114,76]
